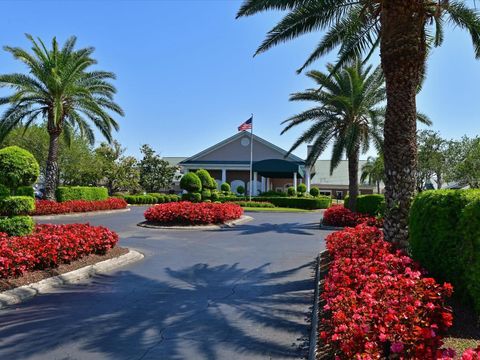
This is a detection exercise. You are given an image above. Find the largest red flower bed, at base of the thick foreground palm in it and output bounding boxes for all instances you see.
[320,224,453,360]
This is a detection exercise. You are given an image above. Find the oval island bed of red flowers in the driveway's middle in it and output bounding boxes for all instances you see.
[145,201,243,225]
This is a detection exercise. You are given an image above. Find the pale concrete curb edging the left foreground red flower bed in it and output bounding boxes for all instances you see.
[0,249,144,309]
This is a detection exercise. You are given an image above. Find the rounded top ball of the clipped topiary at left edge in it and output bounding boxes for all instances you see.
[0,146,40,190]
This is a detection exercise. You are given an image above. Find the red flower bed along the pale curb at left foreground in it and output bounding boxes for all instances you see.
[0,224,118,278]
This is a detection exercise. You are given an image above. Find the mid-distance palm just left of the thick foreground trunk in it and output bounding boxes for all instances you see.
[282,61,385,210]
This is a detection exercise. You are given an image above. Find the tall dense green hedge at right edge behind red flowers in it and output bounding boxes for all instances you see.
[409,190,480,314]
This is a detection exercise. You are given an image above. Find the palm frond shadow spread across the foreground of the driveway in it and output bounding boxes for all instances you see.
[0,263,314,359]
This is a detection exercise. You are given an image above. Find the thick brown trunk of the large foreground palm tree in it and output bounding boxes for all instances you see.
[380,0,426,249]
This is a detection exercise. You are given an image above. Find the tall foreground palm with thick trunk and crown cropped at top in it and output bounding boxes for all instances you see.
[237,0,480,248]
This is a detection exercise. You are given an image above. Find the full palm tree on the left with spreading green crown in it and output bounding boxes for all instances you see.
[0,34,123,200]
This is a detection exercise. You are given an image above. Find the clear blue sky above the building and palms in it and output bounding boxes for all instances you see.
[0,0,480,158]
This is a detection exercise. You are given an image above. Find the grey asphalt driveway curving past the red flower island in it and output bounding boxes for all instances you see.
[0,207,328,360]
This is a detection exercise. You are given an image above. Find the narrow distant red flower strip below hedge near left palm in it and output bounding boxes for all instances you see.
[32,198,128,215]
